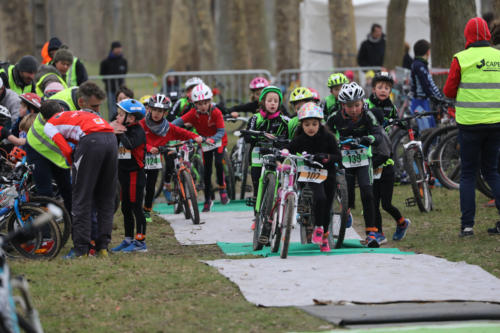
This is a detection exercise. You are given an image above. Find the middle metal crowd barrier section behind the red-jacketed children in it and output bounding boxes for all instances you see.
[162,69,271,106]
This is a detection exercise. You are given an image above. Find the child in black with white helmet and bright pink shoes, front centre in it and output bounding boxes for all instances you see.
[290,102,341,252]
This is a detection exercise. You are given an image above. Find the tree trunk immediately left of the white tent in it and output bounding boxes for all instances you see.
[274,0,300,72]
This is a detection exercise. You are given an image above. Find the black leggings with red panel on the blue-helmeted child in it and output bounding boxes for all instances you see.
[118,169,146,238]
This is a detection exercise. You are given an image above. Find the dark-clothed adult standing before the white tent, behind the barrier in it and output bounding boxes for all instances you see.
[358,23,385,67]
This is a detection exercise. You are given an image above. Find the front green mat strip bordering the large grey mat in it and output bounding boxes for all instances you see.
[217,239,415,257]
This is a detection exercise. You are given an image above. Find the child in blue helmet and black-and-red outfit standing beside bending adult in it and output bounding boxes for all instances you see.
[111,99,147,252]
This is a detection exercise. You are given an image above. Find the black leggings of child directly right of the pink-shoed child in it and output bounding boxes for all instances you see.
[345,165,375,233]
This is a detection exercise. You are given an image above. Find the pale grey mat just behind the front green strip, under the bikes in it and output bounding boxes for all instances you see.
[160,211,361,245]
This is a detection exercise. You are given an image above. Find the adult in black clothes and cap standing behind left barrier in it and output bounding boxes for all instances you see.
[99,41,128,119]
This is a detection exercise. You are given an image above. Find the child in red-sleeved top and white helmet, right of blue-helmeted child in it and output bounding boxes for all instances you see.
[140,94,202,222]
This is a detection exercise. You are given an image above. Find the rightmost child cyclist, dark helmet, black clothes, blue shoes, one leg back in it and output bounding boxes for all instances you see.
[367,72,411,244]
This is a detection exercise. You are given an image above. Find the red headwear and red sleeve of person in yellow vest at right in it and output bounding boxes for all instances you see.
[443,17,491,98]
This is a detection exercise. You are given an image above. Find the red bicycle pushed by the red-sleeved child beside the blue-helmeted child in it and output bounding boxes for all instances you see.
[159,140,200,224]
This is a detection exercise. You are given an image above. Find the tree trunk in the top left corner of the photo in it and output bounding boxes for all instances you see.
[0,0,35,64]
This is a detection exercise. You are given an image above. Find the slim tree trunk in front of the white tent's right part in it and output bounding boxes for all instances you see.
[384,0,408,70]
